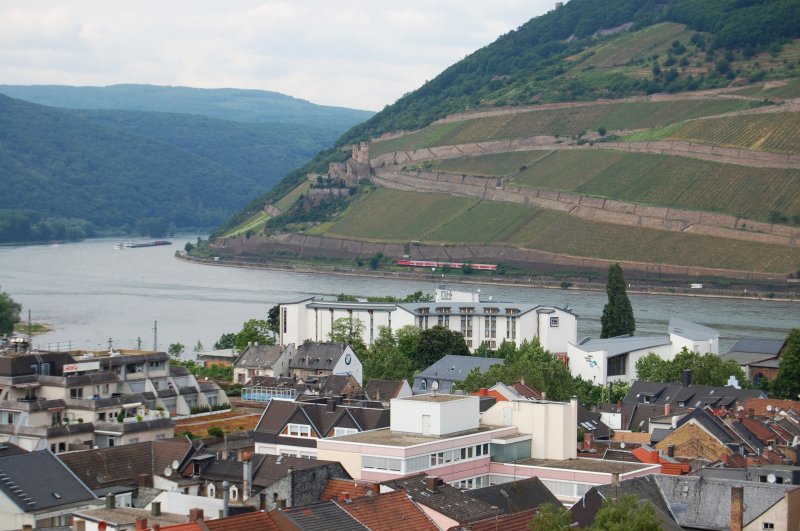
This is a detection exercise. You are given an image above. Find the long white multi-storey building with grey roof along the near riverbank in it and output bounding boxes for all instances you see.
[279,287,578,354]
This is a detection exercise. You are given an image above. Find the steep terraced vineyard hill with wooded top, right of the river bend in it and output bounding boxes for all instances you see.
[214,0,800,282]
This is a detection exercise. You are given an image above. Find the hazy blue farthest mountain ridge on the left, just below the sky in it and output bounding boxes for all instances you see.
[0,85,375,131]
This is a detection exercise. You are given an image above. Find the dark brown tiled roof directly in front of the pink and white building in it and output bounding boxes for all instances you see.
[382,473,496,525]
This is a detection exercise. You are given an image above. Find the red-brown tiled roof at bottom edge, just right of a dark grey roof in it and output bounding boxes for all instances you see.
[335,490,439,531]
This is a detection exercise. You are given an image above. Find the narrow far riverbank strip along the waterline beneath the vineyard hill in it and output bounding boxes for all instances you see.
[175,251,800,302]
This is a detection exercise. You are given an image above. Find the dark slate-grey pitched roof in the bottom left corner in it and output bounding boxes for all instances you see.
[0,450,96,513]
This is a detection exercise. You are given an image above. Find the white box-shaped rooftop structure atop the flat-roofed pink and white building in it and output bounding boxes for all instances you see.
[390,395,480,436]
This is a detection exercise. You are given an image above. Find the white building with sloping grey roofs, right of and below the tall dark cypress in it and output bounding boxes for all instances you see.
[567,319,719,385]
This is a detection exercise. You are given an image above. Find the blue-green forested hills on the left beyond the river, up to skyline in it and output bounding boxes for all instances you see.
[0,85,371,242]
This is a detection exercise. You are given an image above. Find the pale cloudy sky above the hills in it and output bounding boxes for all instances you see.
[0,0,555,111]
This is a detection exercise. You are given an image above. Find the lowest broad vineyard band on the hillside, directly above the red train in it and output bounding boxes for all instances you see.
[327,189,800,273]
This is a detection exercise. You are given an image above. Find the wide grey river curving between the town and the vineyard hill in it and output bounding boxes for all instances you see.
[0,237,800,353]
